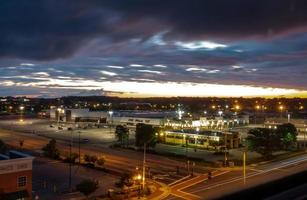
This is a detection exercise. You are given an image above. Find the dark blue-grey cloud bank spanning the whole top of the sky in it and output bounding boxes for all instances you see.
[0,0,307,60]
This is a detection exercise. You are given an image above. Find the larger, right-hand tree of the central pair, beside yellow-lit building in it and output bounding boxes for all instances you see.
[135,124,157,147]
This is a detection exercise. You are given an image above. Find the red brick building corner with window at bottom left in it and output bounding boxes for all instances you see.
[0,151,34,200]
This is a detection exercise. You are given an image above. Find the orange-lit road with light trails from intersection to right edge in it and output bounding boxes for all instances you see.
[161,152,307,200]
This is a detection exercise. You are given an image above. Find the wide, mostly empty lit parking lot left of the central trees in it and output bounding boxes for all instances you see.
[0,119,134,146]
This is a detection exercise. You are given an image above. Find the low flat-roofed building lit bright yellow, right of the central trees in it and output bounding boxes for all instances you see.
[163,131,240,149]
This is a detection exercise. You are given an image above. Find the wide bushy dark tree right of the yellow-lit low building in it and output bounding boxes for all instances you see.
[246,128,280,158]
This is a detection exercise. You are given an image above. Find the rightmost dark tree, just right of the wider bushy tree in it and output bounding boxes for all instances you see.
[276,123,297,149]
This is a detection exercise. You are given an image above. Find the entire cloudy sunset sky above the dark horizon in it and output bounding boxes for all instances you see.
[0,0,307,98]
